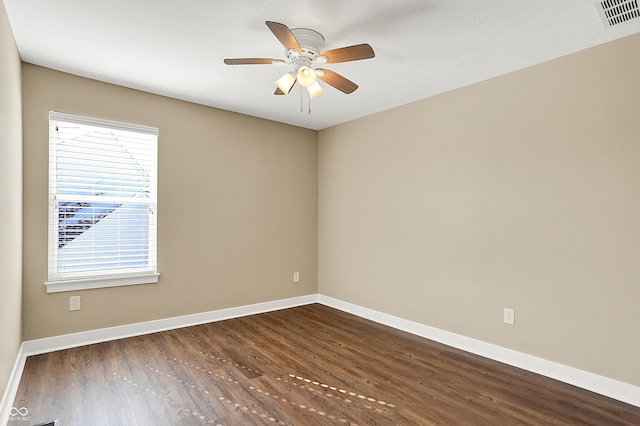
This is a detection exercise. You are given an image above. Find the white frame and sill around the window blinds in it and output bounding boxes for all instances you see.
[45,111,160,293]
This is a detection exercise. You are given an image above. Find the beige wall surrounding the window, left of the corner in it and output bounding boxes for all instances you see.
[22,64,318,340]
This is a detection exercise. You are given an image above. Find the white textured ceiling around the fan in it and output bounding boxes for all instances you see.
[4,0,640,130]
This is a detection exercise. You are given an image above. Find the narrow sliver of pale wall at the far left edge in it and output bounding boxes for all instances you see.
[0,2,22,397]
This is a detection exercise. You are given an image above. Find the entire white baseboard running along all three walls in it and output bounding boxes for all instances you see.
[0,294,640,425]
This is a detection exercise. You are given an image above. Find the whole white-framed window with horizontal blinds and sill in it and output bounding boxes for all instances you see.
[45,111,159,293]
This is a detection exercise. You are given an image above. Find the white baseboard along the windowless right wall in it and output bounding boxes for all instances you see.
[318,295,640,407]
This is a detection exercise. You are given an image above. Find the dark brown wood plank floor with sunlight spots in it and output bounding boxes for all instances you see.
[10,304,640,426]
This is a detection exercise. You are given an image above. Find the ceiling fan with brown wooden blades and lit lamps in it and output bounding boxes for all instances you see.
[224,21,375,99]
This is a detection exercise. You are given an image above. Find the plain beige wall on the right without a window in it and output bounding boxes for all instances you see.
[318,34,640,386]
